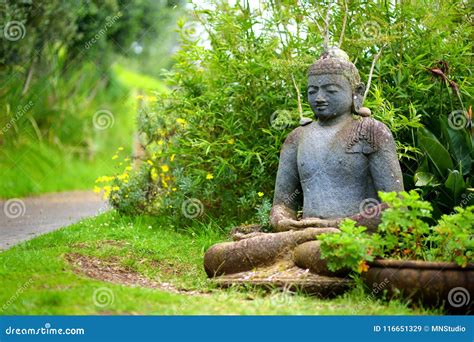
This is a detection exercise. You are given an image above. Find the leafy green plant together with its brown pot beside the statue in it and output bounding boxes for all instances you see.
[318,190,474,312]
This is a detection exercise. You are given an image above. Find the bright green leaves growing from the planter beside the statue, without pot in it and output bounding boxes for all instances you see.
[318,190,474,273]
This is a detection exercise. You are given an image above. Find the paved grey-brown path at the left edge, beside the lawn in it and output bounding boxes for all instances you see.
[0,191,108,250]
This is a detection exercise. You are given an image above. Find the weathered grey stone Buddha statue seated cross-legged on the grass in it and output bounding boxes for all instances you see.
[204,48,403,288]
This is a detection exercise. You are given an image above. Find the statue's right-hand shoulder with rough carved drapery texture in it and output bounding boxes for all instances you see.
[347,117,393,154]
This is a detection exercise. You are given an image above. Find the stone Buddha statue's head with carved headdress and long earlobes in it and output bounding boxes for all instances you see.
[308,48,370,120]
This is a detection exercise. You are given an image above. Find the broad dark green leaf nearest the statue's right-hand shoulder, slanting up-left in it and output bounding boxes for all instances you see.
[418,128,454,177]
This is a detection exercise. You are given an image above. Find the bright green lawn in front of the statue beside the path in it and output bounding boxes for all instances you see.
[0,212,439,315]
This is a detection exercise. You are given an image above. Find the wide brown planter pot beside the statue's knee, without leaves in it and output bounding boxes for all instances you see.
[362,259,474,313]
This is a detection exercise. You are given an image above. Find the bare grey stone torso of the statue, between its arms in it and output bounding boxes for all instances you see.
[297,118,377,218]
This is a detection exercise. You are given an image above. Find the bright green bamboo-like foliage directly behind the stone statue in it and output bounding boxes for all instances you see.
[115,1,472,221]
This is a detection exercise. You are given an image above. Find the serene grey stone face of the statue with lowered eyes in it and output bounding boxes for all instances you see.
[308,74,352,120]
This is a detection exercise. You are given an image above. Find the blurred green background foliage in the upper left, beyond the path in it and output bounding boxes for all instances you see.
[0,0,180,147]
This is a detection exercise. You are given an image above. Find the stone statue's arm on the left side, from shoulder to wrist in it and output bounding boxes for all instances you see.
[270,127,303,231]
